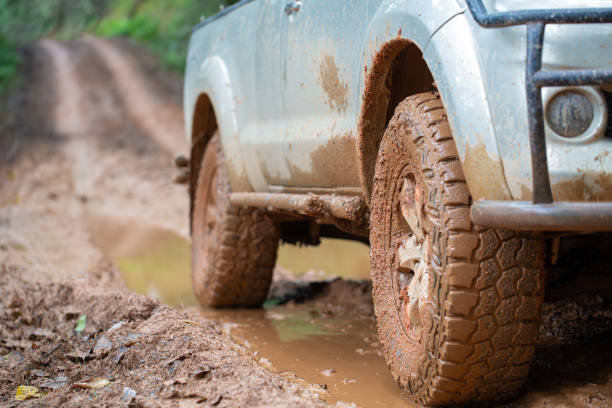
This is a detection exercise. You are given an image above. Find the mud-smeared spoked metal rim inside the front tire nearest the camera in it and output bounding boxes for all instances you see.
[392,174,429,340]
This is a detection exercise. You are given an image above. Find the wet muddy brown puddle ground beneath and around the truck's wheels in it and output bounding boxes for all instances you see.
[89,214,612,407]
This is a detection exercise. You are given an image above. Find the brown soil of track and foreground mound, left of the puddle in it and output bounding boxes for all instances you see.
[0,39,326,407]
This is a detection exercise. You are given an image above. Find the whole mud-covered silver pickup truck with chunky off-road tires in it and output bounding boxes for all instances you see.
[184,0,612,405]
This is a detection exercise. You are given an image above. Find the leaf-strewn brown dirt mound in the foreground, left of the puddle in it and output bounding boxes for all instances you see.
[0,267,324,407]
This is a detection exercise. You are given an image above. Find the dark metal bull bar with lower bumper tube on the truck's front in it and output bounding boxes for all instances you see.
[466,0,612,231]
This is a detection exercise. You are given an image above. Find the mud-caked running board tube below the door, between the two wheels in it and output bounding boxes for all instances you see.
[230,193,367,221]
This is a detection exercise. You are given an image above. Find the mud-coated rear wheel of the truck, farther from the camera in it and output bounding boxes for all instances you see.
[191,135,279,307]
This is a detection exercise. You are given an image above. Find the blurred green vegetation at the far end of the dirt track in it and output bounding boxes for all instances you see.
[0,0,238,95]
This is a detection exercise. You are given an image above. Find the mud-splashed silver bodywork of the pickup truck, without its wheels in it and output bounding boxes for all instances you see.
[184,0,612,207]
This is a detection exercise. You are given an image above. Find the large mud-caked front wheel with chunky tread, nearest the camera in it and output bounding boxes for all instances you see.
[370,92,544,405]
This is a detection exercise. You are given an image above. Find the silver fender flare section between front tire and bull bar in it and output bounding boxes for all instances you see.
[424,13,511,200]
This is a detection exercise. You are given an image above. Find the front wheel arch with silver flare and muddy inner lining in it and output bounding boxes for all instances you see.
[357,4,511,203]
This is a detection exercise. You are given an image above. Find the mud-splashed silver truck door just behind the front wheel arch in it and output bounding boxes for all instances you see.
[278,0,368,193]
